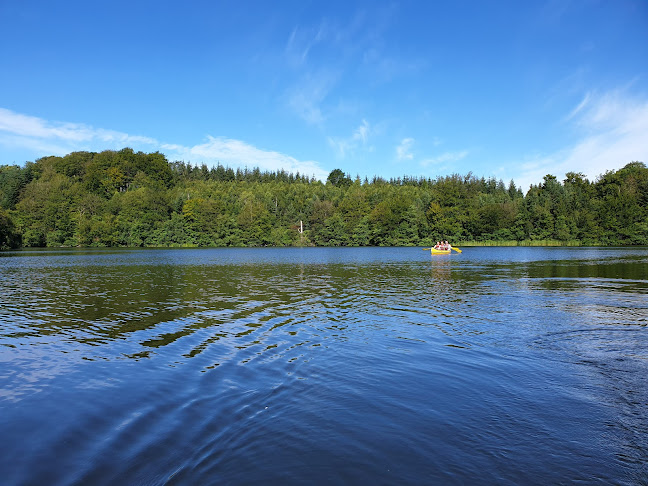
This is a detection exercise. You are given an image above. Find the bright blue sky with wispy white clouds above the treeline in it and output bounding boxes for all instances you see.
[0,0,648,189]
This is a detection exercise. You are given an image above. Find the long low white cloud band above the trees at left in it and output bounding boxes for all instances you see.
[0,108,327,180]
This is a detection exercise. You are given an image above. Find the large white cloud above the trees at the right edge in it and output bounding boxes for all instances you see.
[514,90,648,189]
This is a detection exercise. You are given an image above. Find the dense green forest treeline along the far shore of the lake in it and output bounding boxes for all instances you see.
[0,148,648,248]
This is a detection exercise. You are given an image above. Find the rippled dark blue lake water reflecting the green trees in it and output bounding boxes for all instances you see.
[0,248,648,485]
